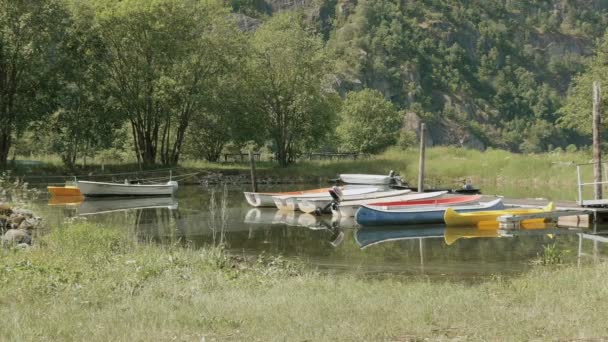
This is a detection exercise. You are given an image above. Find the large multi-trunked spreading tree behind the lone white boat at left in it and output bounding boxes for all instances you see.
[99,0,240,165]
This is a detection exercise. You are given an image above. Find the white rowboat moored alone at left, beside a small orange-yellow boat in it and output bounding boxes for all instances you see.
[77,181,177,197]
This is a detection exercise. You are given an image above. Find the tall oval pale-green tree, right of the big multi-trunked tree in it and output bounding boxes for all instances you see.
[248,13,335,166]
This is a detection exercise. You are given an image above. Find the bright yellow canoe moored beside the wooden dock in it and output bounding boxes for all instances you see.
[444,202,555,229]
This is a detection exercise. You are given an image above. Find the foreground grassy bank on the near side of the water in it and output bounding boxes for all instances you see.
[0,223,608,341]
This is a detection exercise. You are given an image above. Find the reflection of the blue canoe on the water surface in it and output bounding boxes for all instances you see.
[355,224,446,249]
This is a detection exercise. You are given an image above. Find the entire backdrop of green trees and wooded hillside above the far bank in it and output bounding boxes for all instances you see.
[0,0,608,169]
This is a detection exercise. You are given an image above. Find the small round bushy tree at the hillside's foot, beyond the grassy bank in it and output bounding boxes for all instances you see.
[337,89,402,153]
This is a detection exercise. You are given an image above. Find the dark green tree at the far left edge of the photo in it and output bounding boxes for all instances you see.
[0,0,70,169]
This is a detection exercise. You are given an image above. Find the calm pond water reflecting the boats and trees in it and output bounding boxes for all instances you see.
[36,184,608,279]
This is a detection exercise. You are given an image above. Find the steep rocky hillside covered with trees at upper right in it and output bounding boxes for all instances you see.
[302,0,608,152]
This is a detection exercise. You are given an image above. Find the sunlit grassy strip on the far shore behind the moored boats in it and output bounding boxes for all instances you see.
[16,147,591,186]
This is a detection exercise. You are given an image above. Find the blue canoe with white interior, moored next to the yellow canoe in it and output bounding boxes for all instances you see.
[355,198,504,226]
